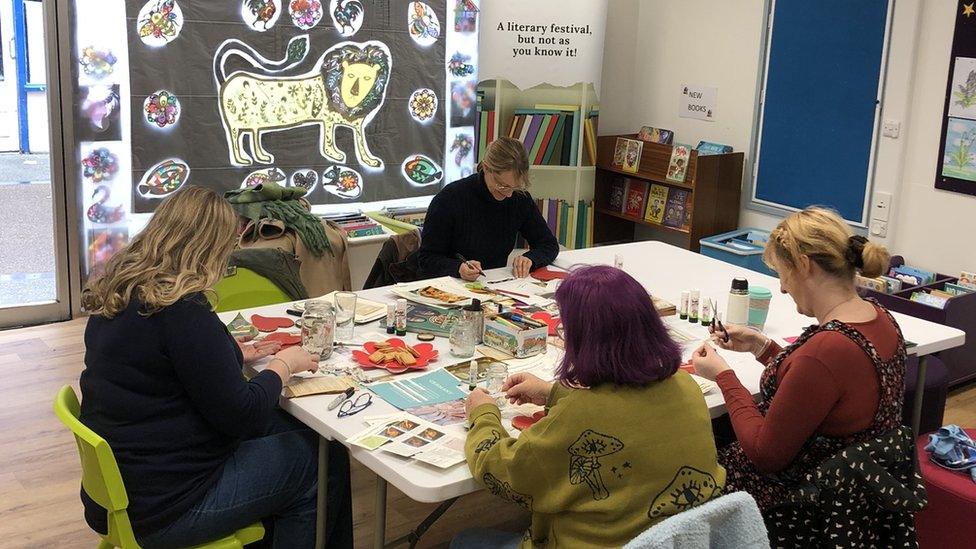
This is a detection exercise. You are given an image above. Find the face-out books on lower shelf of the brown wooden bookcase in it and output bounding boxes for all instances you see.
[608,176,692,229]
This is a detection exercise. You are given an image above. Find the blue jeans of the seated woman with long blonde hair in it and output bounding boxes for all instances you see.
[138,410,352,549]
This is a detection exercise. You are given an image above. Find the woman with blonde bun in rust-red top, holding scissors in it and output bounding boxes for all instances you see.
[693,208,905,522]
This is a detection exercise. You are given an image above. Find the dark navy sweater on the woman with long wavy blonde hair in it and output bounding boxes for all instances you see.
[81,294,281,537]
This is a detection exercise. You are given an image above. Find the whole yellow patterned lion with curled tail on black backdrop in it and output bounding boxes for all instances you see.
[214,35,393,168]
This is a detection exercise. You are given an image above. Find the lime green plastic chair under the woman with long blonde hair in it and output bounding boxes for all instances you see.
[54,385,264,549]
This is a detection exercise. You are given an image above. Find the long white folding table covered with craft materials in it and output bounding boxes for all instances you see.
[220,242,965,548]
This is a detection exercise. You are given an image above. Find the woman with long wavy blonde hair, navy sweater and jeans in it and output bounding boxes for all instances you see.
[81,186,352,547]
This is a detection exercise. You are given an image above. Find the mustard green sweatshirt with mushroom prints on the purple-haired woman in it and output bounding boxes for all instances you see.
[465,370,725,548]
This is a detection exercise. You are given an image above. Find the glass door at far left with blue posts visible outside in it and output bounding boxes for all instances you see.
[0,0,71,328]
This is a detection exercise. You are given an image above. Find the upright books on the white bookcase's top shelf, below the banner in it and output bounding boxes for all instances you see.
[508,104,600,166]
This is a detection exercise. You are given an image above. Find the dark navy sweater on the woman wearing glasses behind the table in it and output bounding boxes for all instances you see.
[417,172,559,278]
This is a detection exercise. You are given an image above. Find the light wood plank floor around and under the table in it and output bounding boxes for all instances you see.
[0,319,976,548]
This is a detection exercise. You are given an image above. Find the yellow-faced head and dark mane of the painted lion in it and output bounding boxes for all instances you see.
[322,41,392,120]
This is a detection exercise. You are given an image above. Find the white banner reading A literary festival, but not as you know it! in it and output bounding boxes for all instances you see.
[479,0,607,96]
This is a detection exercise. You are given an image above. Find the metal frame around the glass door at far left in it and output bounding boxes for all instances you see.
[0,0,75,328]
